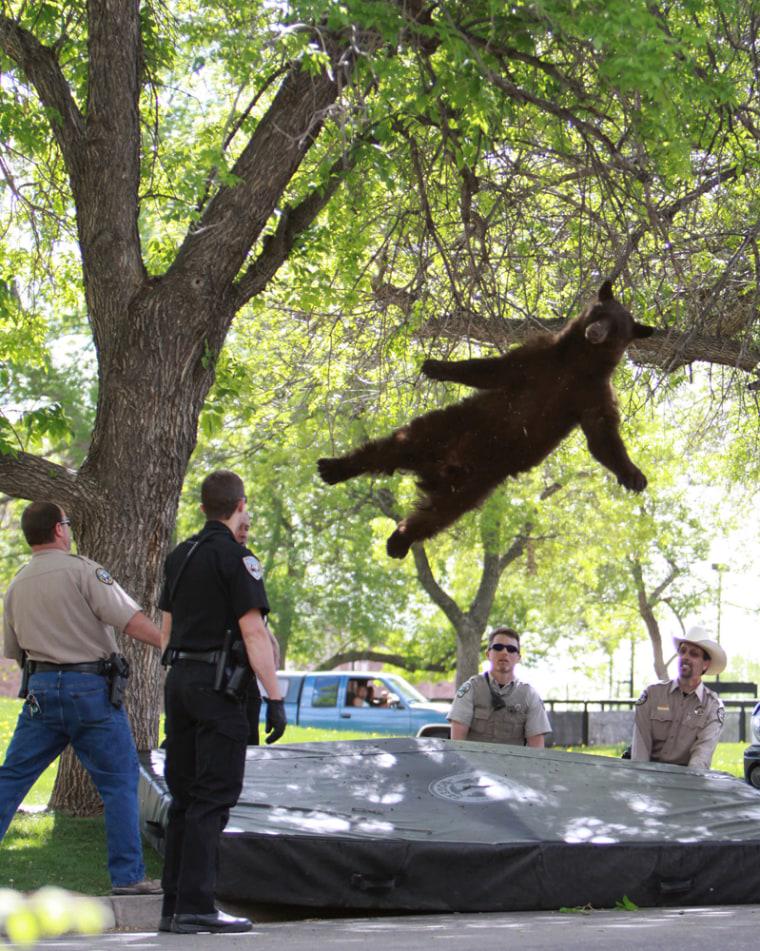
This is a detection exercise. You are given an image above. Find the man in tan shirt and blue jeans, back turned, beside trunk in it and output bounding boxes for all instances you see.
[0,502,161,895]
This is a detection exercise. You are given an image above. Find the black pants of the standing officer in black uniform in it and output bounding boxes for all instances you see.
[162,661,248,915]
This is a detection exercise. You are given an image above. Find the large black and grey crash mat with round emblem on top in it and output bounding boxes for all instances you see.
[140,738,760,911]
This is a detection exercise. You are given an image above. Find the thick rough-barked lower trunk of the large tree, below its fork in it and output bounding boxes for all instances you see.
[43,287,220,815]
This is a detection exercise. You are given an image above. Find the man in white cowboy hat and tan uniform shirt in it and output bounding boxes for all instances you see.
[631,627,727,769]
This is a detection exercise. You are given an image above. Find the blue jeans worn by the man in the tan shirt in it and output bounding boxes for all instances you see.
[0,671,145,886]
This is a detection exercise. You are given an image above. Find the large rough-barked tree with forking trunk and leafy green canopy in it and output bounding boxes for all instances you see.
[0,0,760,820]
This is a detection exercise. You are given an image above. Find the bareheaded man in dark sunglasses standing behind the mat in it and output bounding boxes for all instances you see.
[448,627,551,748]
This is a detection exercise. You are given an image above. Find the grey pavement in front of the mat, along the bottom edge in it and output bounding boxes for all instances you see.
[37,897,760,951]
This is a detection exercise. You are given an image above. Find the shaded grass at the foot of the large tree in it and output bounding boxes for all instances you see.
[0,812,162,895]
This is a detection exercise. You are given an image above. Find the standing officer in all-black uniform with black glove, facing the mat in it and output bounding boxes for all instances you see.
[159,470,286,934]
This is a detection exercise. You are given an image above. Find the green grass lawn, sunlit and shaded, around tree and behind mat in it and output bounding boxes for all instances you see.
[0,697,747,895]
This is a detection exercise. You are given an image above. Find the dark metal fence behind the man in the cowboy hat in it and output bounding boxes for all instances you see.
[544,698,758,746]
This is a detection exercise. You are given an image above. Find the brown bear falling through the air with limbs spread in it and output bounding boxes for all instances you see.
[317,281,654,558]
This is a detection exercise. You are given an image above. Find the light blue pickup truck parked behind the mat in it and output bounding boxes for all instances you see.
[263,670,449,737]
